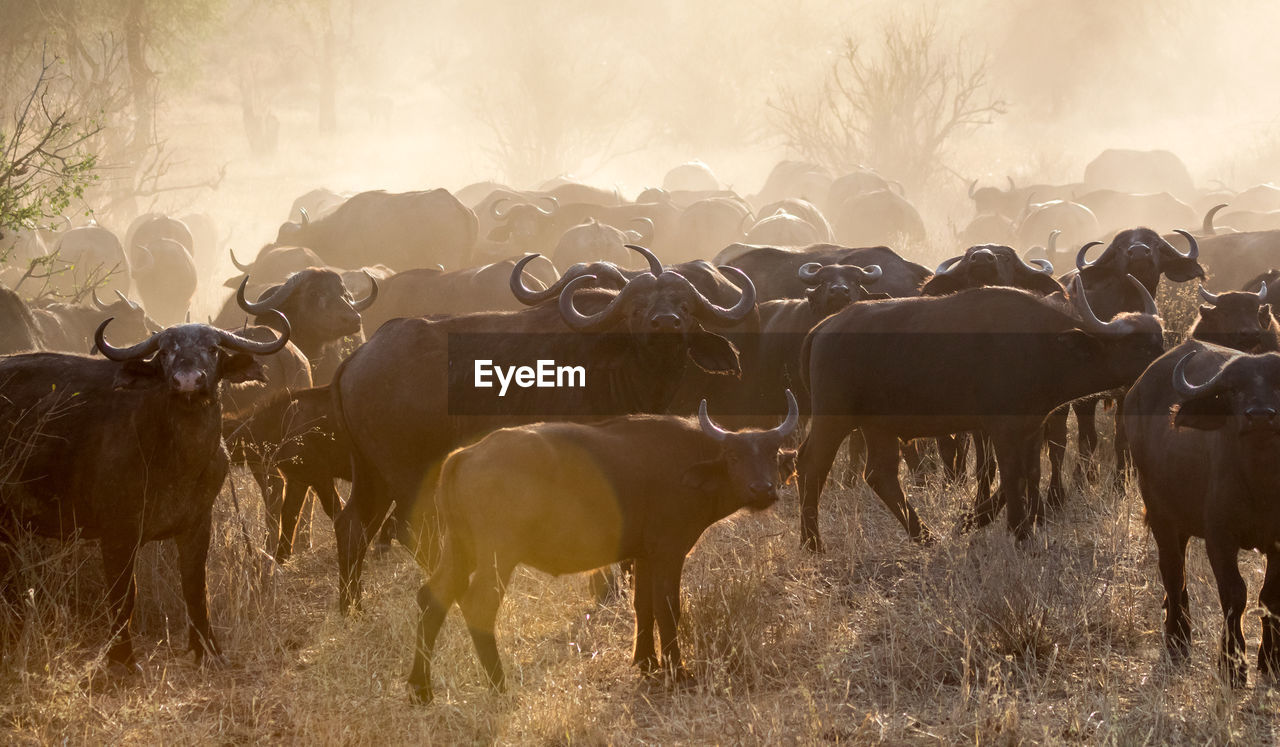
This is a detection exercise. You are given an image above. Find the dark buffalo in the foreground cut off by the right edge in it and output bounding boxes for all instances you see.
[1124,340,1280,687]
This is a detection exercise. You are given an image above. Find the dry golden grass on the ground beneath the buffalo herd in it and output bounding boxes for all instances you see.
[0,434,1280,744]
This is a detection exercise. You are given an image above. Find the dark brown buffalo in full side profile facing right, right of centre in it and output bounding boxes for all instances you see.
[799,280,1164,549]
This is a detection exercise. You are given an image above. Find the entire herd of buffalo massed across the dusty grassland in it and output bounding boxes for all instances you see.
[0,150,1280,702]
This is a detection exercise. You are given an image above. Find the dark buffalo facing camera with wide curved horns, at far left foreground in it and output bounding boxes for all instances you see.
[0,320,288,668]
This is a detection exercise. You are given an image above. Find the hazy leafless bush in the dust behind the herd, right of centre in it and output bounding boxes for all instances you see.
[768,15,1005,185]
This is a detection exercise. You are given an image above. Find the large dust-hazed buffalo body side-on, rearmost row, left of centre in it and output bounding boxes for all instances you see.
[275,189,477,270]
